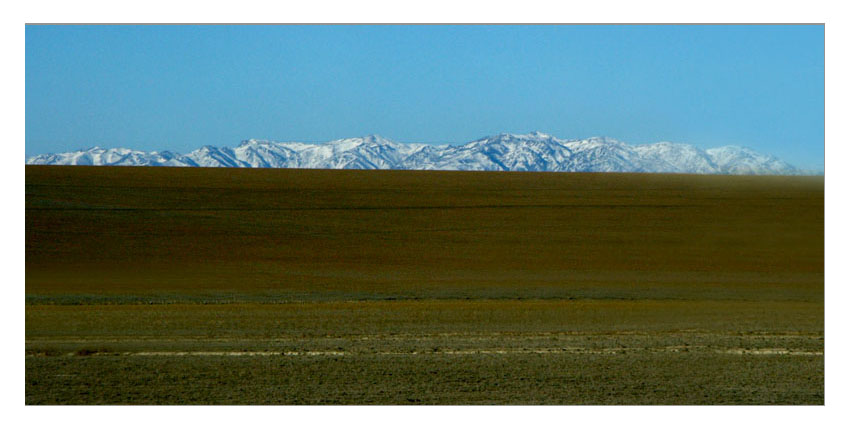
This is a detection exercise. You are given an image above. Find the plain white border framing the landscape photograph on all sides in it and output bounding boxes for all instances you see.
[6,0,850,430]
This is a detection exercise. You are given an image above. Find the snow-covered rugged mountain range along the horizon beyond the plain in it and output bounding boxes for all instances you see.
[27,132,809,175]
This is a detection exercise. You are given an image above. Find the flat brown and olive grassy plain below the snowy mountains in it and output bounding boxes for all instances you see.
[26,166,824,404]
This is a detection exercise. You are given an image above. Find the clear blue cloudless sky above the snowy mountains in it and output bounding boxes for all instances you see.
[26,25,824,169]
